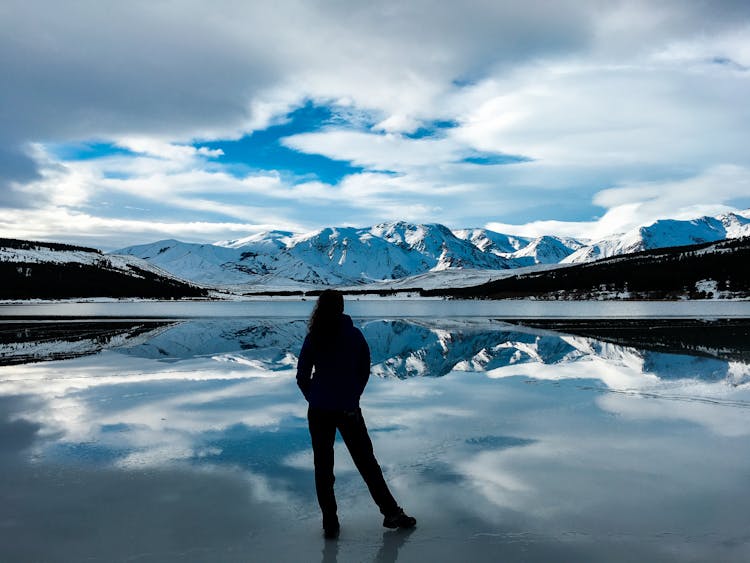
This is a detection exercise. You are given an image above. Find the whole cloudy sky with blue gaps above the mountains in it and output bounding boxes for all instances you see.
[0,0,750,249]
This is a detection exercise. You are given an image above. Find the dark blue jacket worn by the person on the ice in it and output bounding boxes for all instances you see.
[297,314,370,410]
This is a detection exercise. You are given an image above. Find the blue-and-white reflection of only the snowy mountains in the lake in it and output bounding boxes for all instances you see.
[119,319,748,381]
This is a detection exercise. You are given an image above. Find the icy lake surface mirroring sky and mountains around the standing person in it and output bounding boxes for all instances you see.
[0,302,750,563]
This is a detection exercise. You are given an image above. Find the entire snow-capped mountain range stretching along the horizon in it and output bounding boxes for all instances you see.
[117,213,750,289]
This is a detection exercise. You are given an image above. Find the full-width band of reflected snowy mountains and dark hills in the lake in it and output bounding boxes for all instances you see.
[7,319,750,384]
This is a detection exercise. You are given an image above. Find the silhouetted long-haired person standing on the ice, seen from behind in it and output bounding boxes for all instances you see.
[297,289,417,538]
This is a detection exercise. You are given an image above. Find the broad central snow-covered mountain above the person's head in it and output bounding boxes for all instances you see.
[117,222,512,287]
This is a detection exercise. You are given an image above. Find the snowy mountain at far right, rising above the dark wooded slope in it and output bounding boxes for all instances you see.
[561,213,750,264]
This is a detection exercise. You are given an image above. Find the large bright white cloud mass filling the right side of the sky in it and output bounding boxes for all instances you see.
[270,20,750,237]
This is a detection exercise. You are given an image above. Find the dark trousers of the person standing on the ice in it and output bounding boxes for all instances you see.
[307,407,399,523]
